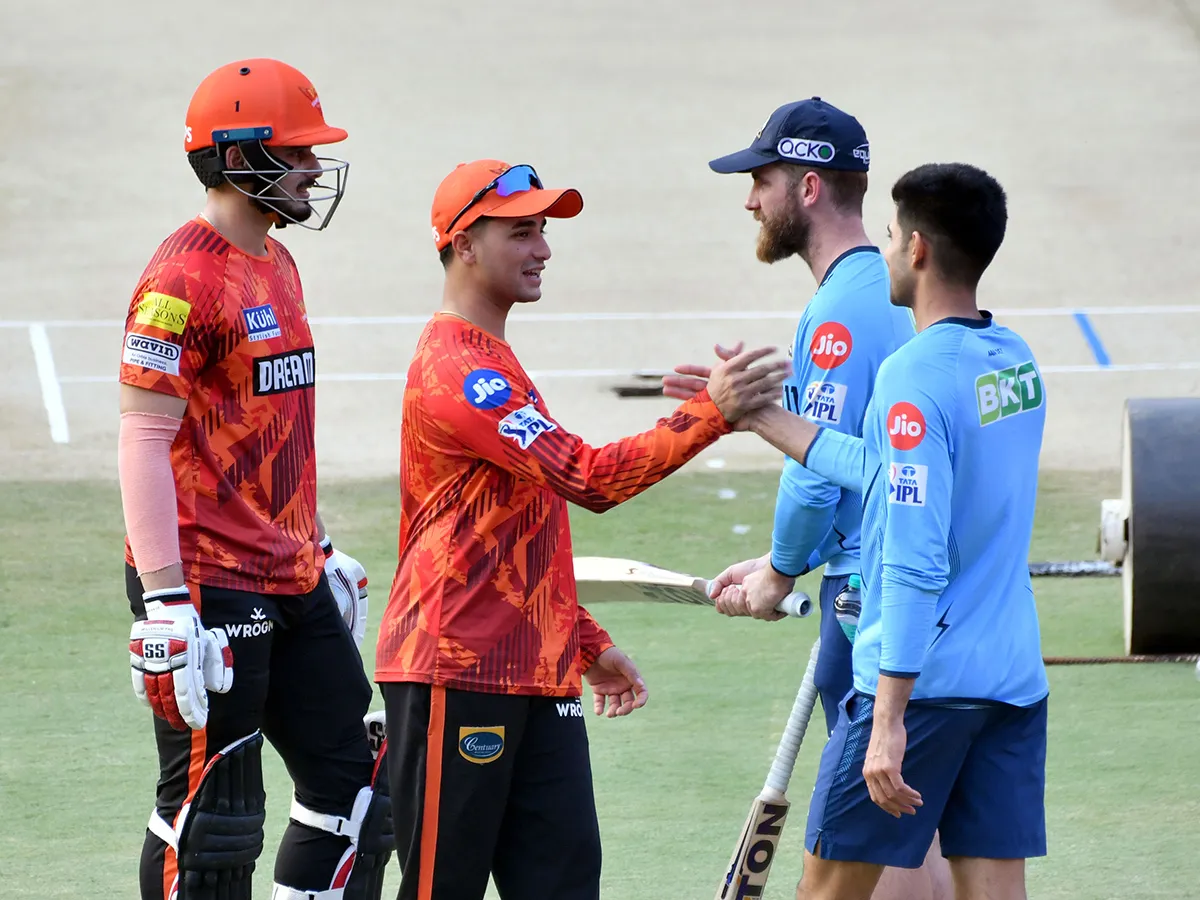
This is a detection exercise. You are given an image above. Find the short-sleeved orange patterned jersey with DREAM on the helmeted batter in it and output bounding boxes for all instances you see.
[120,218,324,594]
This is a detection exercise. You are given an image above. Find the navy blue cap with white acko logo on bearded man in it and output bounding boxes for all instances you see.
[708,97,871,175]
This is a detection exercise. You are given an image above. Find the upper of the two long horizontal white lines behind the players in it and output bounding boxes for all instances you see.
[7,305,1200,328]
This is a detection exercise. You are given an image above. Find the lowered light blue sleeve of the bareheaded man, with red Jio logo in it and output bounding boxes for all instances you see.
[878,366,954,678]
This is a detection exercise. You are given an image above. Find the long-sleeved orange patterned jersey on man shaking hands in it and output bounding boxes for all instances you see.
[376,313,730,696]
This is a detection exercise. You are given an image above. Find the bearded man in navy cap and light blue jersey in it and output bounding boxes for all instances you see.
[700,97,950,900]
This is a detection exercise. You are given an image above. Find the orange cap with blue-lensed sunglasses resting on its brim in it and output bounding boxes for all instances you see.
[431,160,583,252]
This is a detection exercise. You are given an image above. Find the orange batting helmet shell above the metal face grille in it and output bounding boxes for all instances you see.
[184,59,347,151]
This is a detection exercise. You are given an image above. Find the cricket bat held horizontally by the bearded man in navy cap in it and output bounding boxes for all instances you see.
[575,557,812,618]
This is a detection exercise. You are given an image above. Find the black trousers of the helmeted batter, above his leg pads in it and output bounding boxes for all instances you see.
[125,564,373,900]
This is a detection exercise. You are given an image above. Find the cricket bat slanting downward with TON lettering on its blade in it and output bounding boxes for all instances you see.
[715,637,821,900]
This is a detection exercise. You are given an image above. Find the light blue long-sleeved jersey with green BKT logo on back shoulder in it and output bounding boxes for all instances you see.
[805,313,1049,706]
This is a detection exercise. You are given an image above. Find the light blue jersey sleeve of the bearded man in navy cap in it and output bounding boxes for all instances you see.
[770,309,872,575]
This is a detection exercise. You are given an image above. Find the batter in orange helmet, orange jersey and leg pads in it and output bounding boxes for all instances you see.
[118,59,392,900]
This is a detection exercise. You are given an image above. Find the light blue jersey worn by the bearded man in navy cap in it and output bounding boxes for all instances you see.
[770,246,916,575]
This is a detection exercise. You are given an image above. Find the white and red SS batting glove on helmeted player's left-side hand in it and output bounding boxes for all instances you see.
[130,587,233,731]
